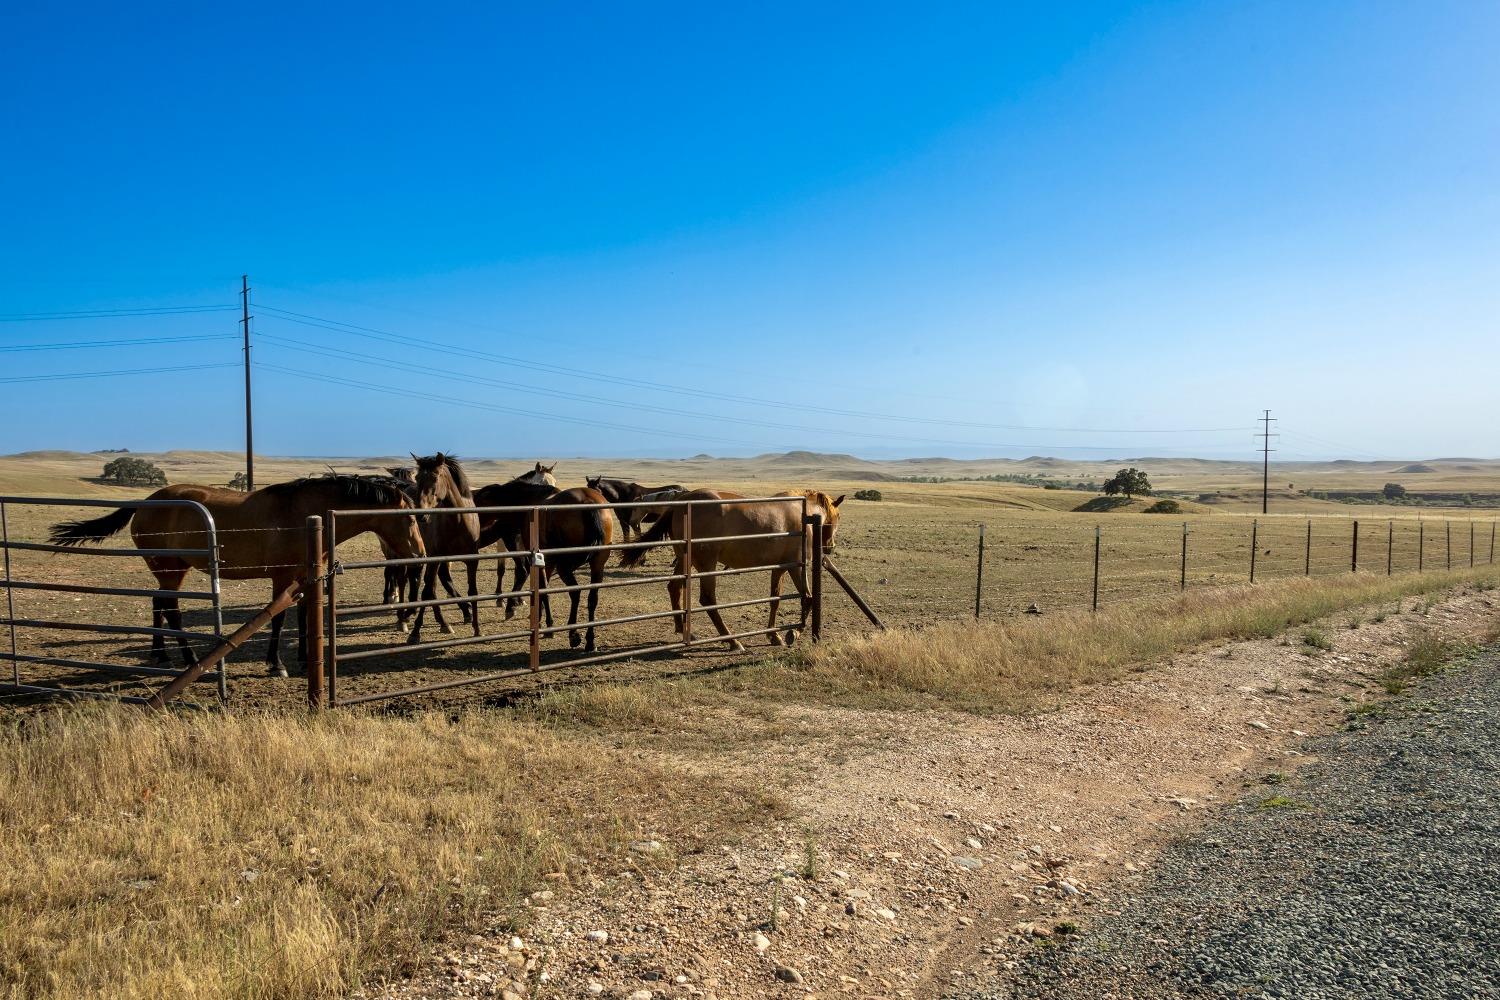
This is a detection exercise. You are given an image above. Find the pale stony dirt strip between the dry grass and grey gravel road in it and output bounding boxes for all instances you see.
[363,591,1497,1000]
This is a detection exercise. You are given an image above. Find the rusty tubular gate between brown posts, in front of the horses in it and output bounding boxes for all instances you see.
[321,496,824,706]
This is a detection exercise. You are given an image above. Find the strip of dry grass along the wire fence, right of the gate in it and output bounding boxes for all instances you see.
[732,570,1494,714]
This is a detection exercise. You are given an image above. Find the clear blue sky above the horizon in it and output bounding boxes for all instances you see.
[0,0,1500,459]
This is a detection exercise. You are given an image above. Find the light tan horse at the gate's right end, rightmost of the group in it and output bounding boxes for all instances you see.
[621,490,845,652]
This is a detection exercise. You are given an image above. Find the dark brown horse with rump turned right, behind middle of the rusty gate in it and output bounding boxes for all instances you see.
[474,479,614,652]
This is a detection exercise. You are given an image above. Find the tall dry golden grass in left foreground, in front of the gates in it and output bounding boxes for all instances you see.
[0,708,767,999]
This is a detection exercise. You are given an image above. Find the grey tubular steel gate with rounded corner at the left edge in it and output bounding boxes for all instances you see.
[0,496,228,703]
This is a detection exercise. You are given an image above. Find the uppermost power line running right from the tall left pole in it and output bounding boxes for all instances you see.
[260,304,1244,433]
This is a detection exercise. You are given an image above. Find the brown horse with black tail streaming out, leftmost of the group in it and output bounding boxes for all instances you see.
[51,475,425,678]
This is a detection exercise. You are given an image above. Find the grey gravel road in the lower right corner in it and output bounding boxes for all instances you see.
[945,648,1500,1000]
